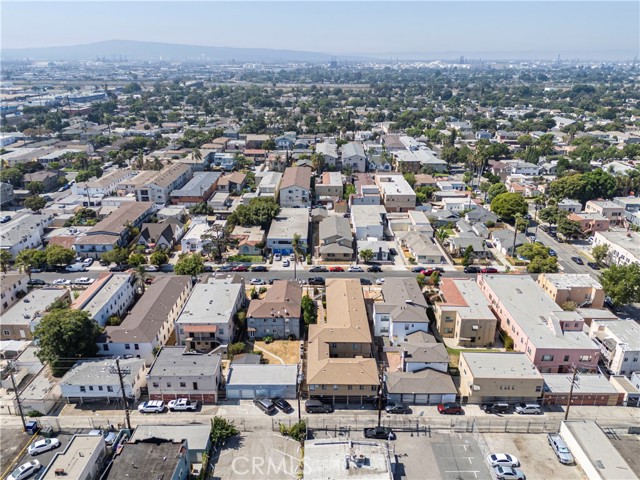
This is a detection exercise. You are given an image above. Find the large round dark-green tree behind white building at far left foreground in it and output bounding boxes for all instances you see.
[33,309,101,377]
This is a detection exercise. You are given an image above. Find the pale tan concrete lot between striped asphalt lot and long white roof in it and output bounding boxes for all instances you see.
[483,433,587,480]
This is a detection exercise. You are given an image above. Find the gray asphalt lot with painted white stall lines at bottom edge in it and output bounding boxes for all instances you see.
[390,432,493,480]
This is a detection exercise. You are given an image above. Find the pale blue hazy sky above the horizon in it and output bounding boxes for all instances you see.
[0,0,640,58]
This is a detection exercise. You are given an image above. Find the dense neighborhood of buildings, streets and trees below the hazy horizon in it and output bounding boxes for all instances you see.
[0,42,640,480]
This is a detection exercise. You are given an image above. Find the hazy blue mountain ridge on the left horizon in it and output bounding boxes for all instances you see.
[0,40,340,63]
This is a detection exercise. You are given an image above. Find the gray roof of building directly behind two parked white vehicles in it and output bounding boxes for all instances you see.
[147,346,222,377]
